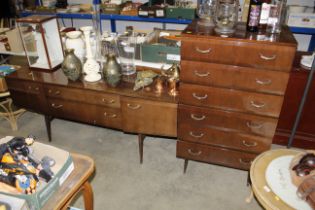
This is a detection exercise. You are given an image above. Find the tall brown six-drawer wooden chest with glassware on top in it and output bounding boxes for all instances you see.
[176,22,296,170]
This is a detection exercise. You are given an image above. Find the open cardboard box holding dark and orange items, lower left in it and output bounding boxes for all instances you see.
[0,137,74,210]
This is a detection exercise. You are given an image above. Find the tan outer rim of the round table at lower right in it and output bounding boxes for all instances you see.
[250,149,300,210]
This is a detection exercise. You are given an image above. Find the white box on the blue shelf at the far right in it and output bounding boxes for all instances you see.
[288,13,315,28]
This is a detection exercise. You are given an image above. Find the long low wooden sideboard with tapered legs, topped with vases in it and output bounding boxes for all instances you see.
[6,67,177,163]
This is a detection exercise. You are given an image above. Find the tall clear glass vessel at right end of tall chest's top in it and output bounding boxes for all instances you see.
[266,0,286,34]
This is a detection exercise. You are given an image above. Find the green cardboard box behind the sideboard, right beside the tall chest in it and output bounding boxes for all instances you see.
[141,29,181,64]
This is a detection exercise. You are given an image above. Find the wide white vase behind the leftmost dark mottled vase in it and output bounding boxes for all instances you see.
[65,31,85,63]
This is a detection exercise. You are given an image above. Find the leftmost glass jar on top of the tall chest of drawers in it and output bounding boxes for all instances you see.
[197,0,216,27]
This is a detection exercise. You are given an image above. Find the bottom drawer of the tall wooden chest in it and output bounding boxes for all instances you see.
[176,141,257,170]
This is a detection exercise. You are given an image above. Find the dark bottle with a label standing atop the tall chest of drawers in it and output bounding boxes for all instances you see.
[246,0,262,32]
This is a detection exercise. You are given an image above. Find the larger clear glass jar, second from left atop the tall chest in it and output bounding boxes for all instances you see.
[214,0,239,35]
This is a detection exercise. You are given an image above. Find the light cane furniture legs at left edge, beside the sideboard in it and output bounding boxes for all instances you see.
[0,92,26,131]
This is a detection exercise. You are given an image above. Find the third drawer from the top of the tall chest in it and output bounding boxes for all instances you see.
[179,83,283,118]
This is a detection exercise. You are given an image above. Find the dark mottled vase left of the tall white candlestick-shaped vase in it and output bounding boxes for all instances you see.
[61,49,82,82]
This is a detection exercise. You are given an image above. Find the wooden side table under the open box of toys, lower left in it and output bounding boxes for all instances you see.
[42,153,95,210]
